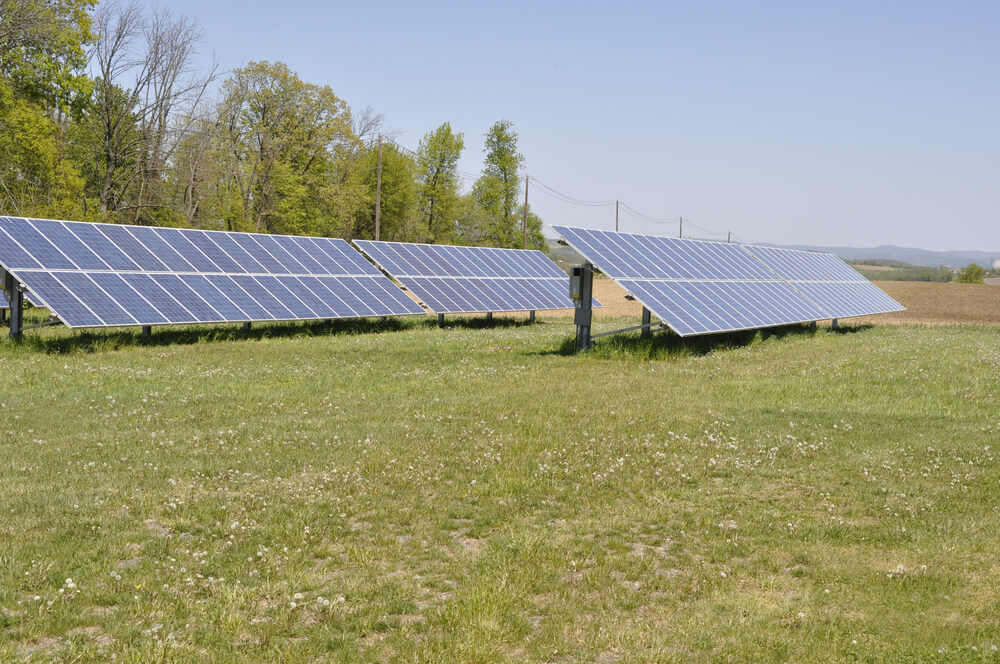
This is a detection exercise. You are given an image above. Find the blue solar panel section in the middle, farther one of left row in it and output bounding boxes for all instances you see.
[354,240,600,314]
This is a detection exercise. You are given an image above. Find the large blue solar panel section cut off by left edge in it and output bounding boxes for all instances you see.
[0,217,425,327]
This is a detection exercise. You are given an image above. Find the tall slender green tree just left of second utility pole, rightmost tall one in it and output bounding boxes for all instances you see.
[472,120,524,247]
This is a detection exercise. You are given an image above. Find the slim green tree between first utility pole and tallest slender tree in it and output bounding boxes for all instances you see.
[417,122,465,242]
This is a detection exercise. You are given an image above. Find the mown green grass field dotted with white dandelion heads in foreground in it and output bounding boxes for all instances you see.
[0,318,1000,662]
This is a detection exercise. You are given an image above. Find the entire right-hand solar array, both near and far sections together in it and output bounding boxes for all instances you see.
[553,226,901,336]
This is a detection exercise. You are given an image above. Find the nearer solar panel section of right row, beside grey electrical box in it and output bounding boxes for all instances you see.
[553,226,830,336]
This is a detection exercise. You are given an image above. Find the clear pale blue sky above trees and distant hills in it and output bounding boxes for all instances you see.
[131,0,1000,255]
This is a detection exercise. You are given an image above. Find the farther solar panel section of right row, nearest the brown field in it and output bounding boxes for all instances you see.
[746,245,905,318]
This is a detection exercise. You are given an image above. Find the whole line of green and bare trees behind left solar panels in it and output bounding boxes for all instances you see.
[0,0,545,248]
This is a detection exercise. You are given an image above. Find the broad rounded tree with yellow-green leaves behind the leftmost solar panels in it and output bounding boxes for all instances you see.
[214,62,365,235]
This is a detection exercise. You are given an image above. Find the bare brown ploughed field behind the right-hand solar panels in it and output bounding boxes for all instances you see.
[545,279,1000,325]
